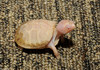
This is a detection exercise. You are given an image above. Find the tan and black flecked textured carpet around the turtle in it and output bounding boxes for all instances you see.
[0,0,100,70]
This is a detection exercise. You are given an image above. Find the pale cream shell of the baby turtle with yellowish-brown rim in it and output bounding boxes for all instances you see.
[15,19,56,49]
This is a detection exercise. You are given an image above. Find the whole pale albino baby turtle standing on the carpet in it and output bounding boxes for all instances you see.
[15,19,75,58]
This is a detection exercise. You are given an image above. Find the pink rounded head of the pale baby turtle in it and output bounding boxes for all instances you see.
[56,20,75,34]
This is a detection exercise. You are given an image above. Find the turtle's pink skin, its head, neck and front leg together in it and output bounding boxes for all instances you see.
[48,20,75,58]
